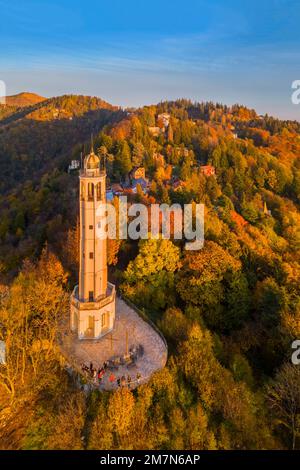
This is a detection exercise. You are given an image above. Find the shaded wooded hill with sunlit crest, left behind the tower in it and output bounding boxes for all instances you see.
[0,96,125,271]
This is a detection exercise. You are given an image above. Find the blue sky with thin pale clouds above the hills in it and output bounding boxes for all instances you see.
[0,0,300,120]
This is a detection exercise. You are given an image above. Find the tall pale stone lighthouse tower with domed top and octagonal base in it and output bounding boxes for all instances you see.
[71,149,115,339]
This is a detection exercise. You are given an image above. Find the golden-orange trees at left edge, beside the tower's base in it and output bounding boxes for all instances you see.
[0,247,69,403]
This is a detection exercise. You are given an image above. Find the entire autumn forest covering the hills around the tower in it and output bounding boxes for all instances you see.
[0,96,300,449]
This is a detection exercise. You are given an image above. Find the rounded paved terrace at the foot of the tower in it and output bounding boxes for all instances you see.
[62,297,167,390]
